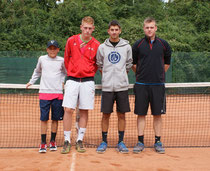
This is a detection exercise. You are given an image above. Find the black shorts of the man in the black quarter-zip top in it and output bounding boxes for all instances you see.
[134,84,166,115]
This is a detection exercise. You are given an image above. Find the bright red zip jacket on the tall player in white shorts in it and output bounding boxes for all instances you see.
[64,34,100,78]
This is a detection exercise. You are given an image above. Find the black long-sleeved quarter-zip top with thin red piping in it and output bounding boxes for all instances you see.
[132,36,171,83]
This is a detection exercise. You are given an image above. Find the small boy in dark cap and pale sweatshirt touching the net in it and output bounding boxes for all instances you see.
[26,40,66,153]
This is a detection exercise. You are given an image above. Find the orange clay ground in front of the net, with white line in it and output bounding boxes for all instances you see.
[0,147,210,171]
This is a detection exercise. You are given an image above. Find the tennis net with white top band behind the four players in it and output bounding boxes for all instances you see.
[0,82,210,148]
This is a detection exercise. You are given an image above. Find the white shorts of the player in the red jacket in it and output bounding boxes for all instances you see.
[62,80,95,110]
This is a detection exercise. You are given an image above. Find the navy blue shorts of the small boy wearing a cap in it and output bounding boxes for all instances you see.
[39,99,64,121]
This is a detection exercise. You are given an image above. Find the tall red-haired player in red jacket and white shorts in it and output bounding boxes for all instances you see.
[61,16,100,154]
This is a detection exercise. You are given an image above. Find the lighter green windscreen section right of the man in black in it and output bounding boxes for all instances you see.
[172,52,210,82]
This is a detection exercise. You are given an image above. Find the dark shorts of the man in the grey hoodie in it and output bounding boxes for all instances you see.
[101,90,130,114]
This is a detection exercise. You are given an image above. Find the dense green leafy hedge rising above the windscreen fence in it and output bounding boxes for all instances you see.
[0,0,210,52]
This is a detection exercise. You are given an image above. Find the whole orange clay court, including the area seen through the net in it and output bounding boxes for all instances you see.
[0,83,210,171]
